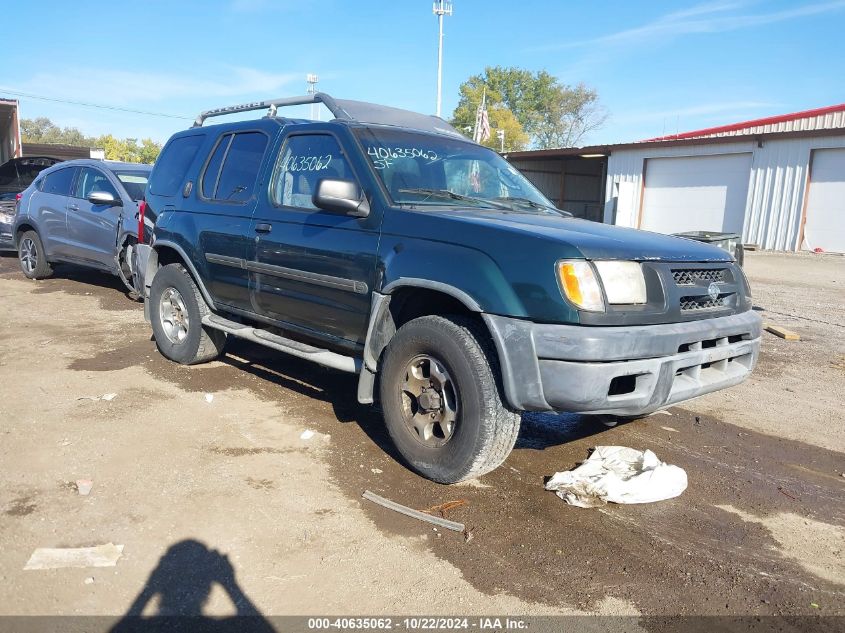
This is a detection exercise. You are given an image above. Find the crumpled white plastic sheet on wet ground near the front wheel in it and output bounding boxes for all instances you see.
[546,446,687,508]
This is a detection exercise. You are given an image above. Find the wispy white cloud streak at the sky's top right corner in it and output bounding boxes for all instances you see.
[530,0,845,51]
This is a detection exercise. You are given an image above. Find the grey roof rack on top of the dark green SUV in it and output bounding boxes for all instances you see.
[193,92,464,138]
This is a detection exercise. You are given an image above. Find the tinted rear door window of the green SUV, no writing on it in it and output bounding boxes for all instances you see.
[201,132,267,202]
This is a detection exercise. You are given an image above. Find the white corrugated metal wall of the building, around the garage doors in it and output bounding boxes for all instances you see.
[604,136,845,250]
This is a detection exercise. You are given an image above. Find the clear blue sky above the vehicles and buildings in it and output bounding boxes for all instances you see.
[0,0,845,143]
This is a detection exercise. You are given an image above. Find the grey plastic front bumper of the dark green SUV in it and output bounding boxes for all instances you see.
[484,310,762,415]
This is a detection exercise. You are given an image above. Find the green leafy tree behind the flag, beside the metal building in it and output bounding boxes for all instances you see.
[453,66,607,148]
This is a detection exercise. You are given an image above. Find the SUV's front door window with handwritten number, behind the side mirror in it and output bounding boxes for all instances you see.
[273,134,355,209]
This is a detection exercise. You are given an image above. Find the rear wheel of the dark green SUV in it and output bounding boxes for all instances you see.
[148,264,226,365]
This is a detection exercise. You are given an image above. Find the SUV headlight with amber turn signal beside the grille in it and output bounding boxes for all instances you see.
[557,259,648,312]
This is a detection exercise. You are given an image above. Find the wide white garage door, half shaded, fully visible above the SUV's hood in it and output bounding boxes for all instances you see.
[640,154,751,233]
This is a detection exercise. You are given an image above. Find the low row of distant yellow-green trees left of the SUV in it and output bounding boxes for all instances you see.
[21,117,161,164]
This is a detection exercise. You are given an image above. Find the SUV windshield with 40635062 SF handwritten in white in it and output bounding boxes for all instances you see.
[356,128,569,215]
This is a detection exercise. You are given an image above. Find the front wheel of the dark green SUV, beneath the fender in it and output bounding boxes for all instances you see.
[380,316,520,484]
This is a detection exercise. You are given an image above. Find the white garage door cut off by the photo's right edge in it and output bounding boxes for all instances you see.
[804,149,845,253]
